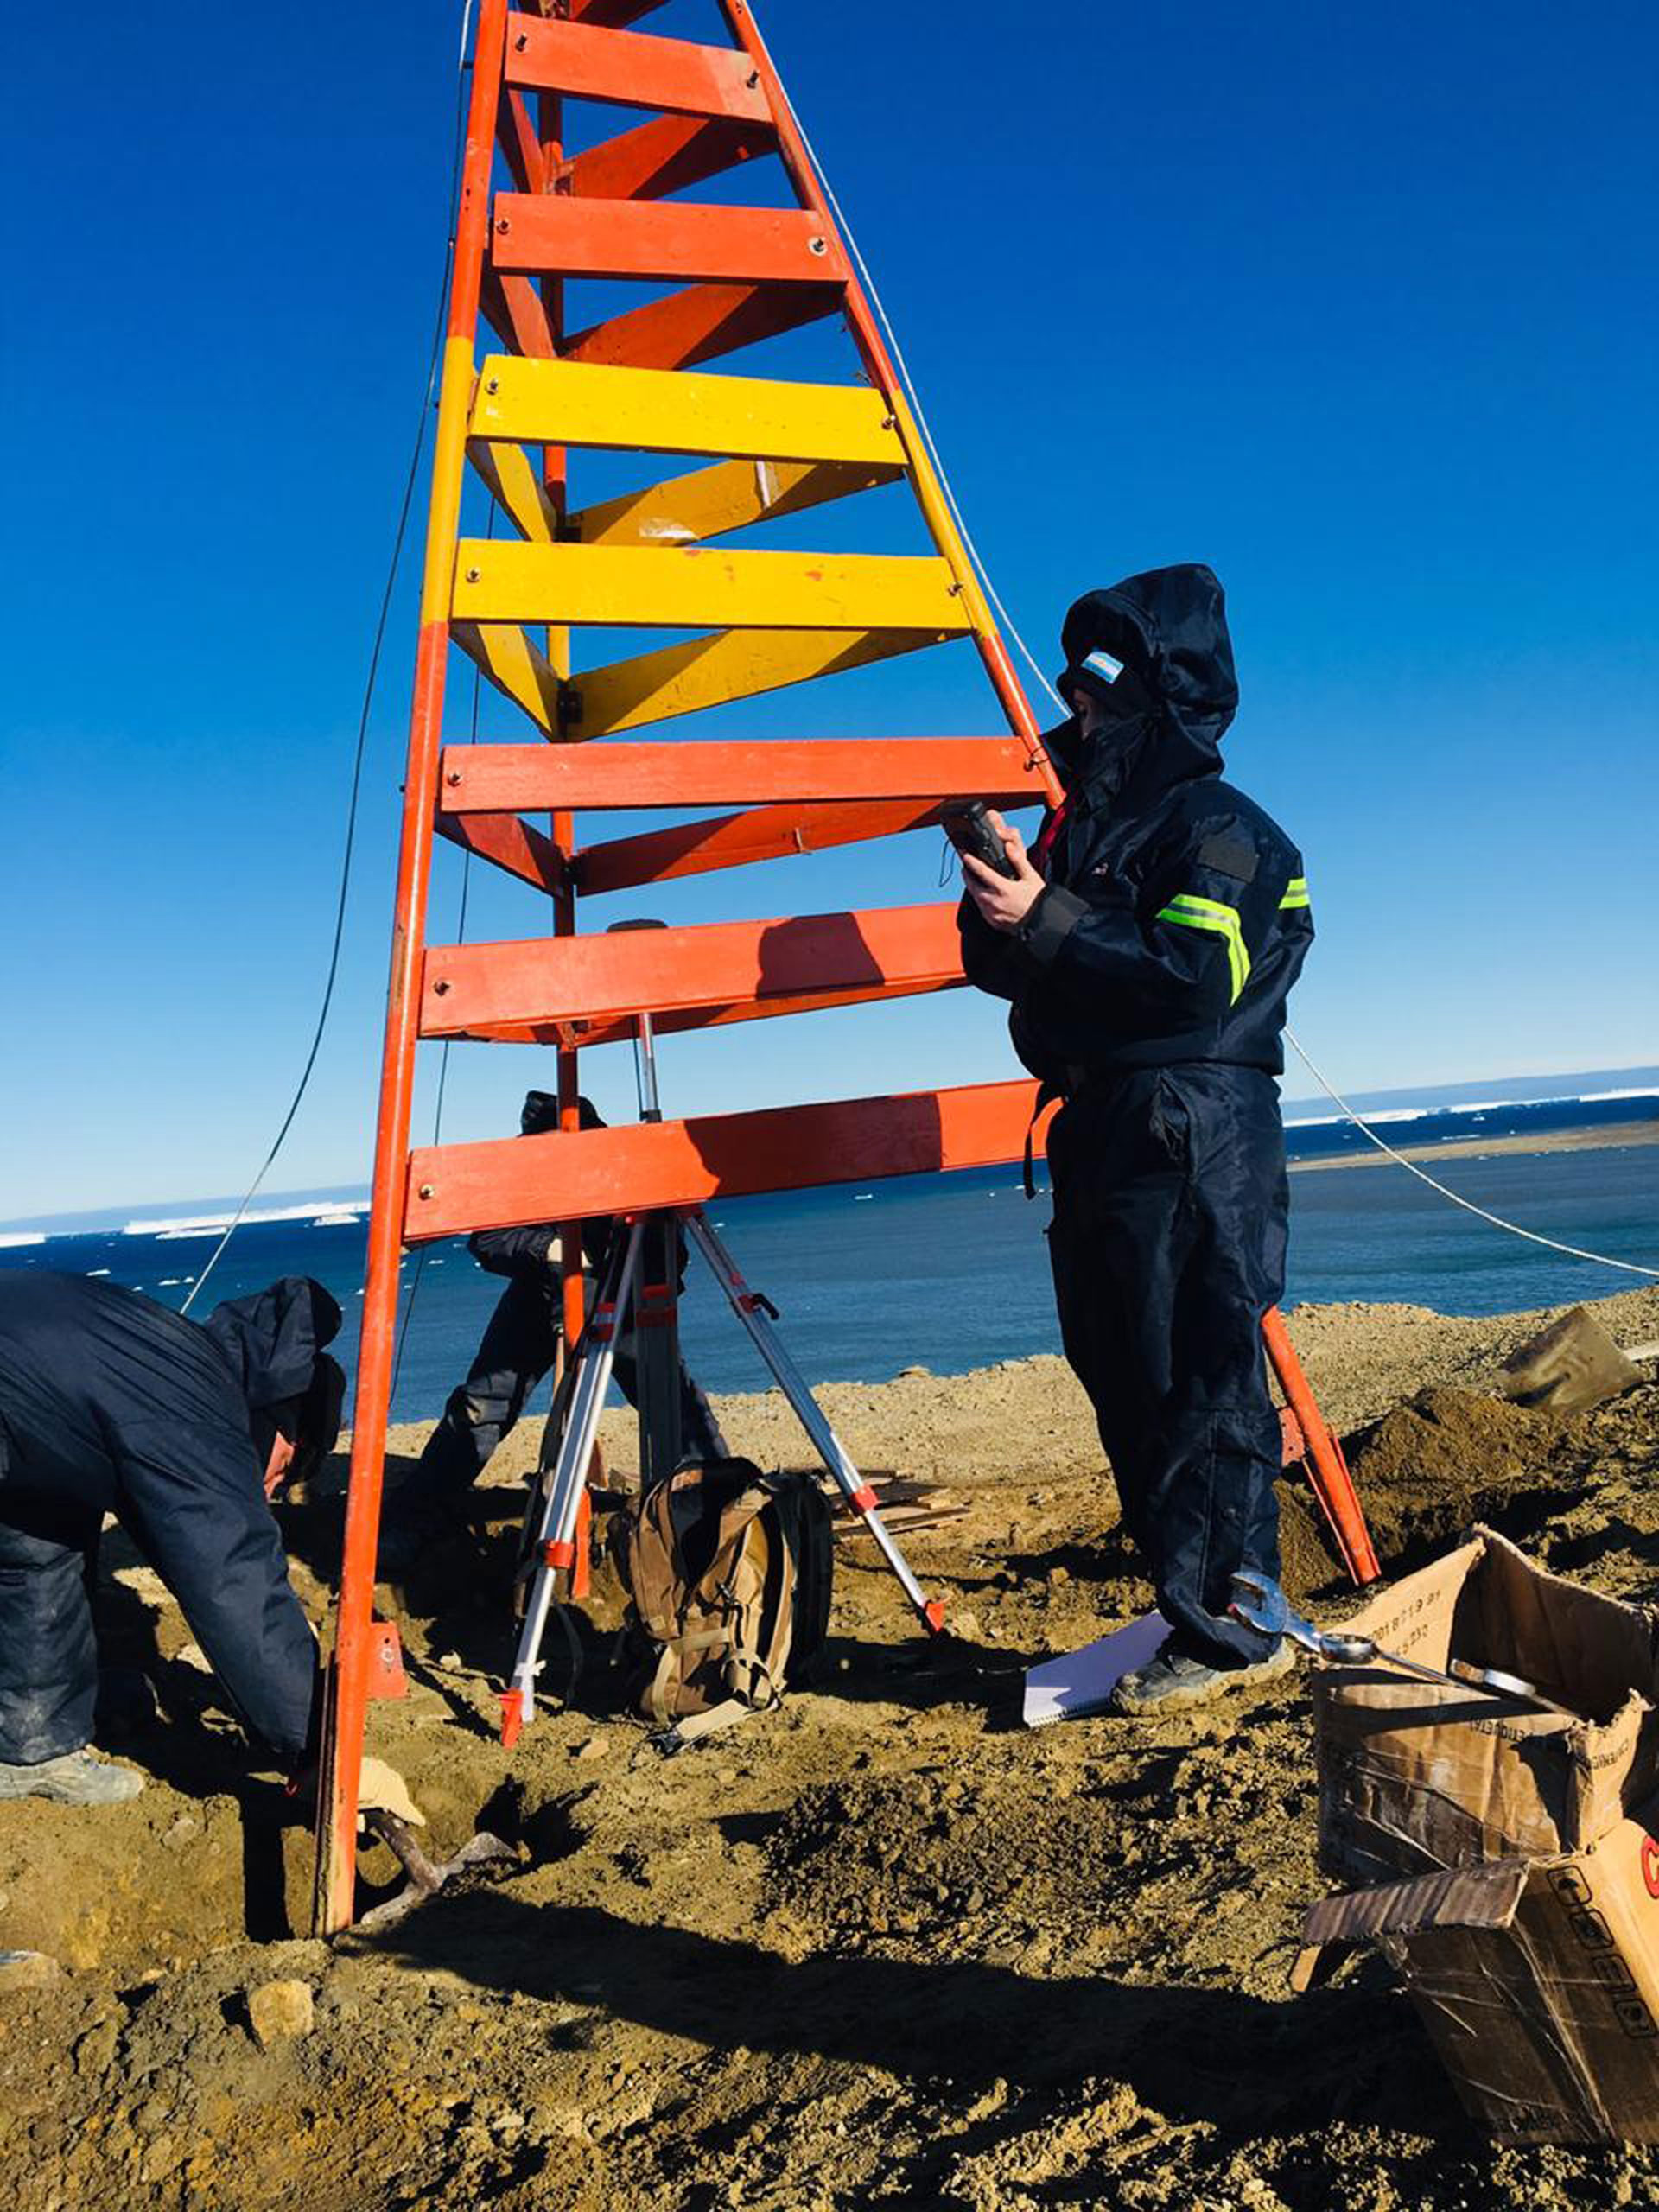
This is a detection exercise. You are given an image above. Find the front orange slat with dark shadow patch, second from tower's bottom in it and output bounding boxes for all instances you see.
[420,900,963,1038]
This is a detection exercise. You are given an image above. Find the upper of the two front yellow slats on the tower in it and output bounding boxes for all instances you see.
[471,354,905,467]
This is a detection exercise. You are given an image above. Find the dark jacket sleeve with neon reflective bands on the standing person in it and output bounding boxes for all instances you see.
[1013,823,1292,1028]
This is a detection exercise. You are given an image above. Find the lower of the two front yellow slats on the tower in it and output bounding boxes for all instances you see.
[454,537,969,632]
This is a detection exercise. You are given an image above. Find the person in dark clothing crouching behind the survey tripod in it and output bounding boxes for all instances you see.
[380,1090,728,1573]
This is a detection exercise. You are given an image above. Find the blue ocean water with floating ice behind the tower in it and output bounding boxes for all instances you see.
[0,1093,1659,1421]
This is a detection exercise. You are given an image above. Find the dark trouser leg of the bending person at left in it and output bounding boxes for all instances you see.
[0,1482,99,1767]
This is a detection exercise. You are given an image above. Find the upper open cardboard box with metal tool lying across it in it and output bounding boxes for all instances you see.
[1314,1529,1659,1887]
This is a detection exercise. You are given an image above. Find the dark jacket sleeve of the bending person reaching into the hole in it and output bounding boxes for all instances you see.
[113,1418,319,1765]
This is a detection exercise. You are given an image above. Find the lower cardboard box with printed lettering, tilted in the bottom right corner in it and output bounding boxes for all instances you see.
[1305,1812,1659,2144]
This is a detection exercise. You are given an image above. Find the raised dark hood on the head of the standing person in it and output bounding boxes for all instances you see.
[1044,562,1239,805]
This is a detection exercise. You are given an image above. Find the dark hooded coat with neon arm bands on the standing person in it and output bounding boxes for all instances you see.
[960,564,1314,1089]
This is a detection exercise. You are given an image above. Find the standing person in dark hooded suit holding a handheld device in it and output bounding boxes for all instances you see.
[960,566,1314,1712]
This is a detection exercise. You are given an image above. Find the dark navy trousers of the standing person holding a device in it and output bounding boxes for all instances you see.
[1048,1064,1289,1666]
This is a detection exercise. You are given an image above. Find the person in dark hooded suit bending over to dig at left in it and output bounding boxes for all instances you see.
[0,1269,345,1805]
